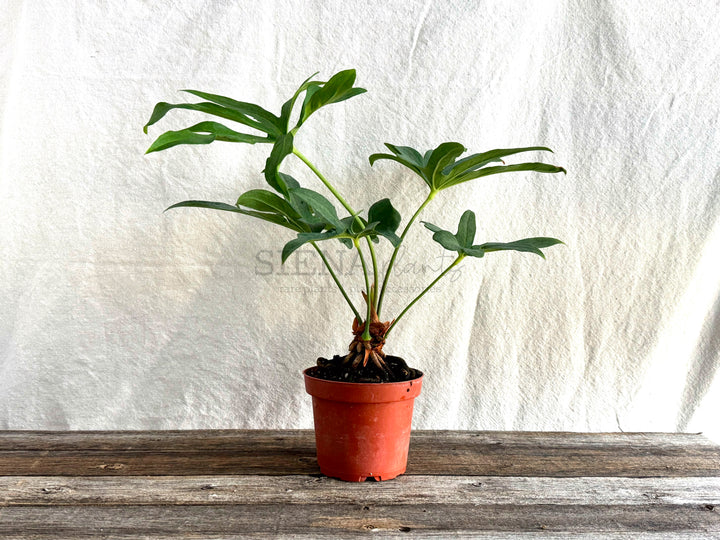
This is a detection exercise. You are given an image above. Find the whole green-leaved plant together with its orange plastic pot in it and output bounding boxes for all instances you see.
[143,70,565,481]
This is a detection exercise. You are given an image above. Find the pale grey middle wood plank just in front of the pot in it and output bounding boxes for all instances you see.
[0,476,720,510]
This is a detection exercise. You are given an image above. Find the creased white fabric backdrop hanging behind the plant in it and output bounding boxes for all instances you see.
[0,0,720,436]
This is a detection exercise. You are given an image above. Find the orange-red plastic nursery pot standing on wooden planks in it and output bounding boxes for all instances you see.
[303,368,422,482]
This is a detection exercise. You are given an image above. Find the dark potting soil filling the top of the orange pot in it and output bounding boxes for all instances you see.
[307,355,422,383]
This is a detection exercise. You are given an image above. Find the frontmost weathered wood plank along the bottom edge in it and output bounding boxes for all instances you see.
[0,504,720,538]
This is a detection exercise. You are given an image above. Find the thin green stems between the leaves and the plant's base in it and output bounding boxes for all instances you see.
[293,148,465,341]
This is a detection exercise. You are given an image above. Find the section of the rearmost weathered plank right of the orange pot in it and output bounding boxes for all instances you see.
[408,432,720,477]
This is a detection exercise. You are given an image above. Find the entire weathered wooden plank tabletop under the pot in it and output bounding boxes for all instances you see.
[0,430,720,539]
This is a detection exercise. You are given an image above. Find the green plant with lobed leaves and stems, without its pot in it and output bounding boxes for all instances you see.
[143,70,565,382]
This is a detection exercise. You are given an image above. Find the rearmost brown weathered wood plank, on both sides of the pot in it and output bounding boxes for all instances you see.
[0,430,720,477]
